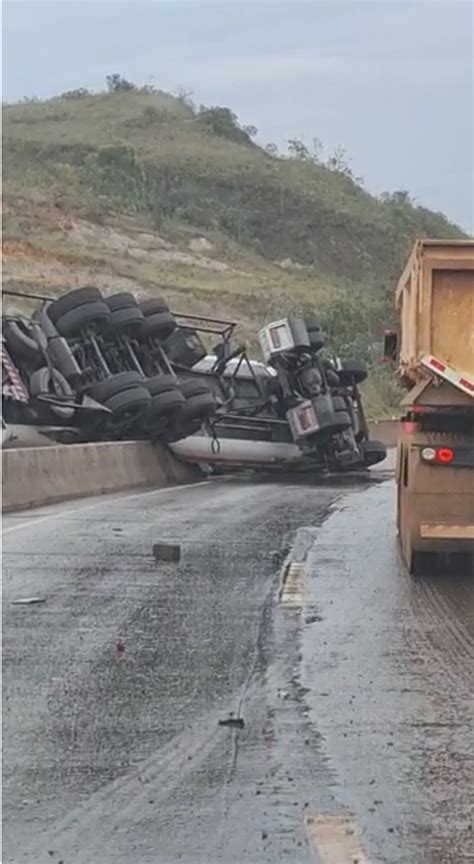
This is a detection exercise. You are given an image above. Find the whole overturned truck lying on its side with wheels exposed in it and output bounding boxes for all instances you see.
[2,287,386,471]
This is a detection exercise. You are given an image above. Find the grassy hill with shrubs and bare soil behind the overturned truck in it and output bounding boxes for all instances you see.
[3,79,463,410]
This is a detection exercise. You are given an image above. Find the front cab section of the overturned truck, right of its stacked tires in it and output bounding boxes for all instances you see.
[171,316,386,472]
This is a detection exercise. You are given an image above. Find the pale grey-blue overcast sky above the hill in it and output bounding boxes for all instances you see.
[3,0,474,231]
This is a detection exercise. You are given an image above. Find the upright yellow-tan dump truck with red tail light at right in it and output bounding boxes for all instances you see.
[386,240,474,572]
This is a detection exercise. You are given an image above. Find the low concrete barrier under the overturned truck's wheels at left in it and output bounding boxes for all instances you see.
[2,441,202,511]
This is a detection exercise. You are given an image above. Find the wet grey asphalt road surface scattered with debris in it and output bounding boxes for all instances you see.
[3,475,474,864]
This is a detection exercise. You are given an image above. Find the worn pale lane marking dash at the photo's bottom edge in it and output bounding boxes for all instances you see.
[304,813,370,864]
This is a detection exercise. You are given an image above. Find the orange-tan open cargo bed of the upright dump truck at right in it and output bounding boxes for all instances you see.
[396,240,474,384]
